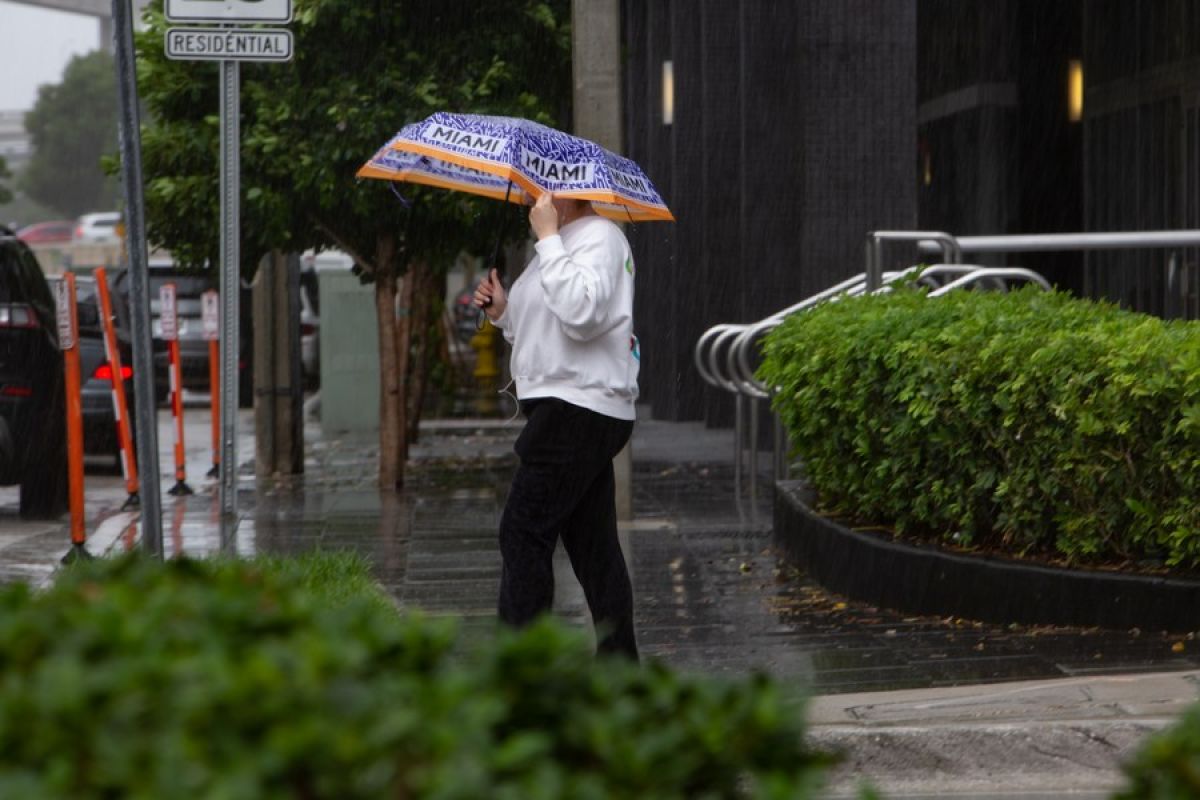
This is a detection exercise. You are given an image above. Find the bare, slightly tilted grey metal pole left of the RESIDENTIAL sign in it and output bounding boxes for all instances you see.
[113,0,162,558]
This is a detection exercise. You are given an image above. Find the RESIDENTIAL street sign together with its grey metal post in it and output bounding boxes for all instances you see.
[164,0,292,522]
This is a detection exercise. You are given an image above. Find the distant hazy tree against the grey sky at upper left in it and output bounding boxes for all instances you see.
[20,50,116,217]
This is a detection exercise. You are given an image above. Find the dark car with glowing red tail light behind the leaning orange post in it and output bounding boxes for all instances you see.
[49,276,137,464]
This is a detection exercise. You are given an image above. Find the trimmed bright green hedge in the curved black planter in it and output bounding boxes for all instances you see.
[758,289,1200,567]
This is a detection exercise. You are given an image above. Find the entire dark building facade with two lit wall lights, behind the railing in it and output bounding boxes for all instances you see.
[622,0,1200,425]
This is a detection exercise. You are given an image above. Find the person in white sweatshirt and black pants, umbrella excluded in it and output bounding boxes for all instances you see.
[474,192,640,660]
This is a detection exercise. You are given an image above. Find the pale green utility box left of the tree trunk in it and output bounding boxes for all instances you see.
[316,253,379,434]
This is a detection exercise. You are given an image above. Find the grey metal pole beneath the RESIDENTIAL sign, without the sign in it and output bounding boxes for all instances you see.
[221,61,241,520]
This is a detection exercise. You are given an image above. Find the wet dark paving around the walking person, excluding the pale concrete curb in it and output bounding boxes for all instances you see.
[0,403,1200,694]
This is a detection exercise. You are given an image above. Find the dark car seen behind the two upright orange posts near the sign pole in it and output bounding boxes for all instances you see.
[112,261,254,408]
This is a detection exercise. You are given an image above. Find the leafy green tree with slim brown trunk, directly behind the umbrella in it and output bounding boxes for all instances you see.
[138,0,571,487]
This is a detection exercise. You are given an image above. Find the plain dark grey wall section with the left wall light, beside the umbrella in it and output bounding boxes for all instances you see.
[622,0,917,422]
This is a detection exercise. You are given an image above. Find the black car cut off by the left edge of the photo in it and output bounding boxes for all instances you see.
[0,227,67,517]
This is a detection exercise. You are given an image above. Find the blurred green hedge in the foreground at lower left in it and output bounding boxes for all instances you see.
[0,558,829,800]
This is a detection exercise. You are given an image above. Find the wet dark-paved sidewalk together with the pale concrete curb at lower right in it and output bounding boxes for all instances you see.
[0,407,1200,800]
